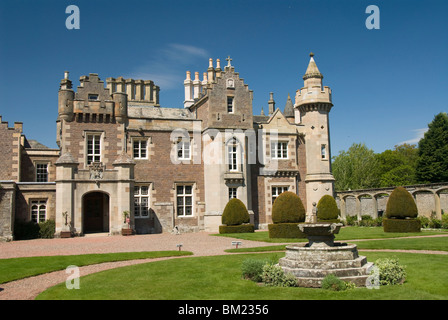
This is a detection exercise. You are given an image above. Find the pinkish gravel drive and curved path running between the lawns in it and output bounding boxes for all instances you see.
[0,232,448,300]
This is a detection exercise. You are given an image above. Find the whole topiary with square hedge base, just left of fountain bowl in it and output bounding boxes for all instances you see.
[268,191,306,238]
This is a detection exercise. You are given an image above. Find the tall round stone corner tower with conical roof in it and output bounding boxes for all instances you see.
[294,53,334,218]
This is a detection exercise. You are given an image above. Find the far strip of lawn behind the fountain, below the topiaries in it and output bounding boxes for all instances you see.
[214,227,447,243]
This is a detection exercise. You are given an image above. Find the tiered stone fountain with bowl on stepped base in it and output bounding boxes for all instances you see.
[279,210,373,288]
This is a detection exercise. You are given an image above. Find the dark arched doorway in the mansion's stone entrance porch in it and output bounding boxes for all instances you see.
[82,192,109,233]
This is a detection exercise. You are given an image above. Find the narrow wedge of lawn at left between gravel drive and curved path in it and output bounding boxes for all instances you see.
[0,251,192,283]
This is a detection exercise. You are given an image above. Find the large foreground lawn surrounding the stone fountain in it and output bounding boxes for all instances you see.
[38,252,448,300]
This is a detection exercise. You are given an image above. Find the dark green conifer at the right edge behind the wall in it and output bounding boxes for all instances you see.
[416,112,448,183]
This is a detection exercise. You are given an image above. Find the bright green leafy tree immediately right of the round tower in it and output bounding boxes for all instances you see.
[332,143,380,191]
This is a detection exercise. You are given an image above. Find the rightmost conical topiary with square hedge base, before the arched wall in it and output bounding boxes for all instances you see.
[383,187,421,232]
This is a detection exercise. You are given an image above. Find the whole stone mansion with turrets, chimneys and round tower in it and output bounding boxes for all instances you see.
[0,54,334,240]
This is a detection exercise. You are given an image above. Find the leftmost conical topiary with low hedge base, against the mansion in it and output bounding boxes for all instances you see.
[219,198,254,233]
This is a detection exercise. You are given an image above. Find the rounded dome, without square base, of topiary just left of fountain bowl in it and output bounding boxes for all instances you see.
[272,191,305,223]
